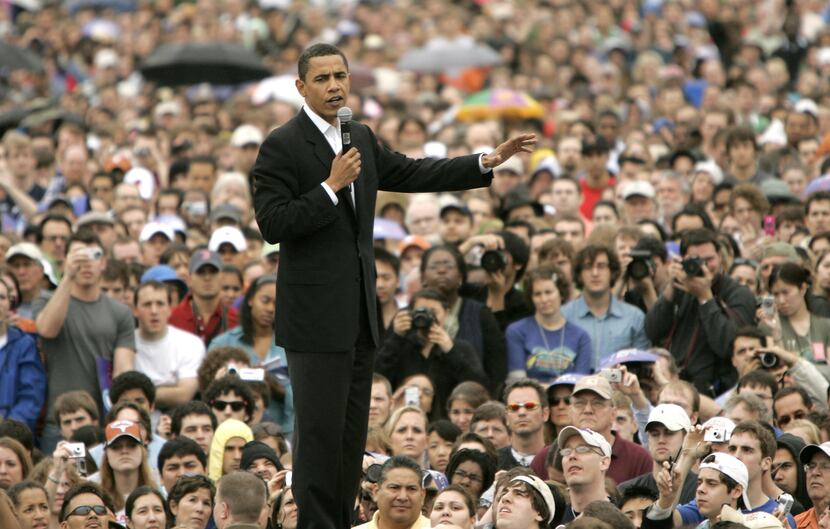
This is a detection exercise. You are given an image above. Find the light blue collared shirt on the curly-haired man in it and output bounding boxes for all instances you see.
[562,295,651,370]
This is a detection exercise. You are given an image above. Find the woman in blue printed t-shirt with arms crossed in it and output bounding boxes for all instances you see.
[507,265,593,384]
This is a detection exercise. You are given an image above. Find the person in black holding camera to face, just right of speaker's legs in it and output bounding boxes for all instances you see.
[375,289,487,420]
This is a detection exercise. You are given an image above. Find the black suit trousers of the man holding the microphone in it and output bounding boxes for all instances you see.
[287,274,374,529]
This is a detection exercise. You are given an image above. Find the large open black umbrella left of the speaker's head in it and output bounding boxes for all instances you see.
[139,42,271,86]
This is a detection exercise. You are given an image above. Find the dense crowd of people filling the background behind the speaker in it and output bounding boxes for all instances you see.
[0,0,830,529]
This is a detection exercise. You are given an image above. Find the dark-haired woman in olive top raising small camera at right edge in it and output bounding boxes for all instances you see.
[757,263,830,371]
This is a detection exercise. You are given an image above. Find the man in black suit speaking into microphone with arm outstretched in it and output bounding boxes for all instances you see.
[253,44,535,529]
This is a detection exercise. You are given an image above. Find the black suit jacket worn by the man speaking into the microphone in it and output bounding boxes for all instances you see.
[253,110,493,352]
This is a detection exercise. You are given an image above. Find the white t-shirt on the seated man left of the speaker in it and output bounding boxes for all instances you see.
[135,325,205,386]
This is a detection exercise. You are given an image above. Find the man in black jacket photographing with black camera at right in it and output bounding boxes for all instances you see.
[645,229,755,396]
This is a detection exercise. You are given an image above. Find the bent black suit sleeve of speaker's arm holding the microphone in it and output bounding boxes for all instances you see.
[253,131,337,243]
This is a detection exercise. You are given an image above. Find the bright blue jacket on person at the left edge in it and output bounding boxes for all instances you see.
[0,327,46,431]
